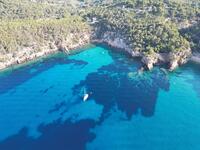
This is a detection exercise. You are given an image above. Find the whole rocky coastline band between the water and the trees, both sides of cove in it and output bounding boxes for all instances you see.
[0,33,197,71]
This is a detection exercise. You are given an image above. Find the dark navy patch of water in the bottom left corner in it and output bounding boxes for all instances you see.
[0,120,95,150]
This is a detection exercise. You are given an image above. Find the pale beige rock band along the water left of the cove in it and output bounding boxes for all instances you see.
[0,33,90,70]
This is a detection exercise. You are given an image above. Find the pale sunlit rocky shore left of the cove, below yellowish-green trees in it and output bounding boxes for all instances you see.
[0,34,90,71]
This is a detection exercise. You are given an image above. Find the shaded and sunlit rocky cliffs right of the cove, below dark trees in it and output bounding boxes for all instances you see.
[93,33,192,71]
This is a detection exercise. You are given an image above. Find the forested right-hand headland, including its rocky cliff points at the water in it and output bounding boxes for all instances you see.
[80,0,200,69]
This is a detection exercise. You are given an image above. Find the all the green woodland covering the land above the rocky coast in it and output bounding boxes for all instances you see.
[0,0,200,65]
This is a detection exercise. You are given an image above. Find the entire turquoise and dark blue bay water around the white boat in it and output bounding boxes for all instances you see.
[0,46,200,150]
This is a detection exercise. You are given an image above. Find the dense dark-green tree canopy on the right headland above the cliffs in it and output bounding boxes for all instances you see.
[82,5,190,54]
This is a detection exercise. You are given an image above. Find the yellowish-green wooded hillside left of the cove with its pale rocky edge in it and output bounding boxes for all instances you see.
[0,0,90,69]
